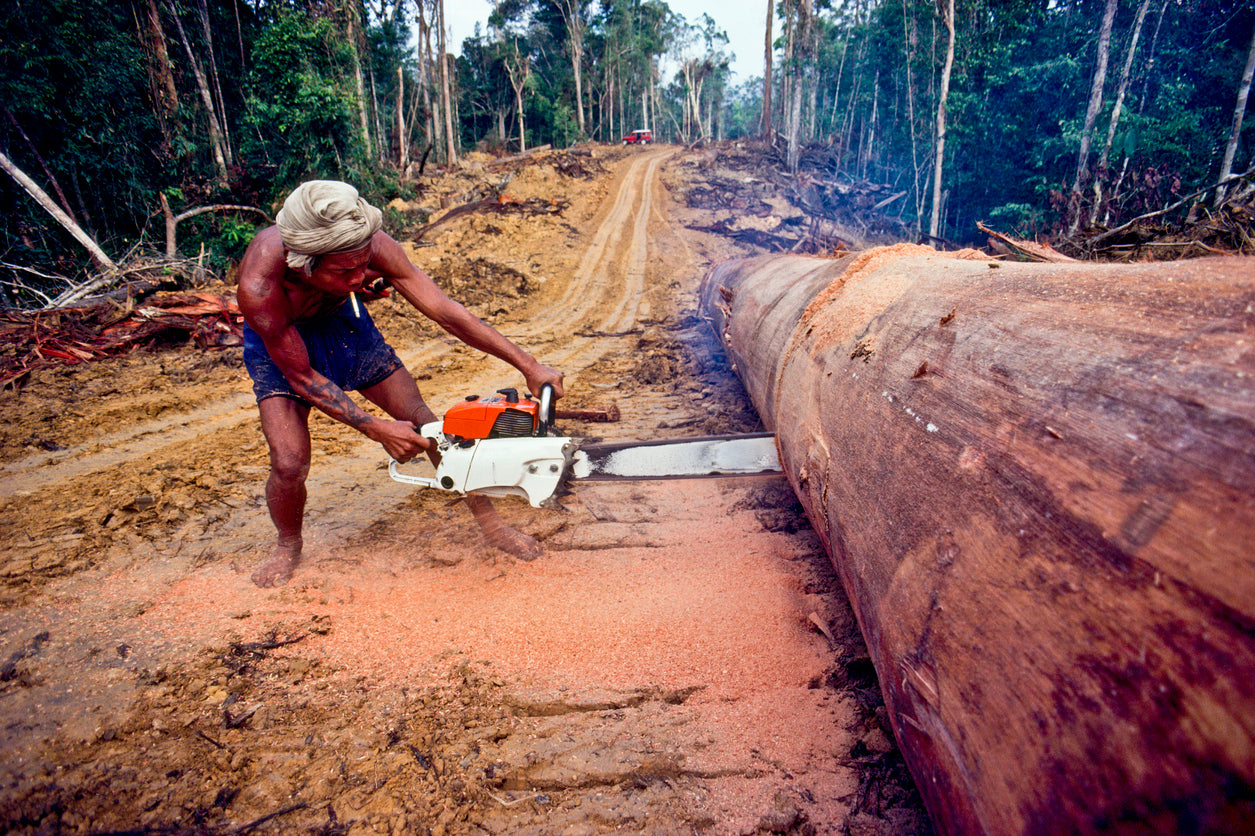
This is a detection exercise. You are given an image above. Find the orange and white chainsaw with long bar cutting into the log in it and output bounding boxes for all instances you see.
[388,385,781,508]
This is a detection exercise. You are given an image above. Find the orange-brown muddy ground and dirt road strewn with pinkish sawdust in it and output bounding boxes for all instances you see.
[0,147,929,833]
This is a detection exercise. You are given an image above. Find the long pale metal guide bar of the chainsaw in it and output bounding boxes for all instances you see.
[569,433,781,482]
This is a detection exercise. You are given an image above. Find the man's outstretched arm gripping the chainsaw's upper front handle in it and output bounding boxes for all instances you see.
[370,232,563,398]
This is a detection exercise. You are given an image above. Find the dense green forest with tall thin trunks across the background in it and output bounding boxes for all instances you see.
[0,0,1255,308]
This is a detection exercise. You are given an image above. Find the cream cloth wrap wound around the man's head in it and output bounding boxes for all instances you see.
[275,180,383,275]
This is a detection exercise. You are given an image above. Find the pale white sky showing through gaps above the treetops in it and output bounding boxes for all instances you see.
[444,0,778,84]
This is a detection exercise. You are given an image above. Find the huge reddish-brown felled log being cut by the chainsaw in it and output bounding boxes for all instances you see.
[702,245,1255,833]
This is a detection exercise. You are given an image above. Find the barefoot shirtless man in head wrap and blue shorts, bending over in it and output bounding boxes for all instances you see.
[238,181,562,586]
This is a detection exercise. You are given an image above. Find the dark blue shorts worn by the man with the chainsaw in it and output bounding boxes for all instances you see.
[243,299,402,407]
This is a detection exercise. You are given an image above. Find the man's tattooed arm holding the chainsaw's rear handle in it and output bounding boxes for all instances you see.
[238,233,430,462]
